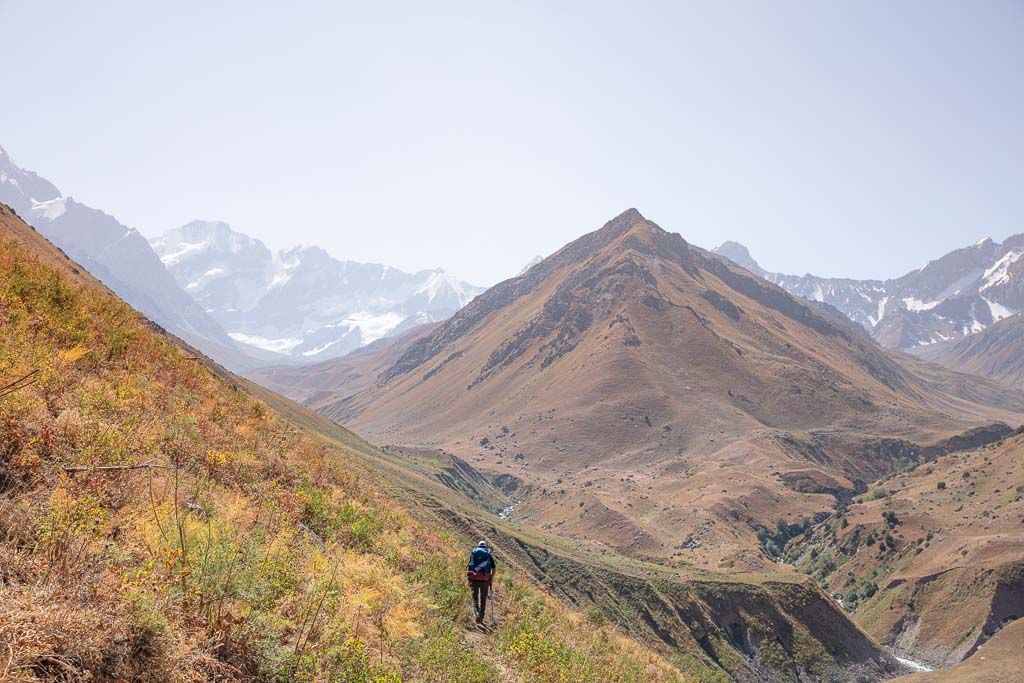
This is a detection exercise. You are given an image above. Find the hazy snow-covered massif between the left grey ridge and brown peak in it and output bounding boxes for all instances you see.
[152,221,483,361]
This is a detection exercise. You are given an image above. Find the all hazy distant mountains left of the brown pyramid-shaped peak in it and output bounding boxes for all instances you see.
[0,143,482,370]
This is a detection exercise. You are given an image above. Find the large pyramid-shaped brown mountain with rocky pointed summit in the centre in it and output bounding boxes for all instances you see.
[253,210,1024,569]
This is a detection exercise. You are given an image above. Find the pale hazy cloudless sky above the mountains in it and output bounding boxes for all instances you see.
[0,0,1024,285]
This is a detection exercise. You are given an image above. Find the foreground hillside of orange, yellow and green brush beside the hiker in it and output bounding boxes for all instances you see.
[0,207,690,681]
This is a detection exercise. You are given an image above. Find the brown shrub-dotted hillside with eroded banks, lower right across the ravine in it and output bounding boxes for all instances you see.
[791,433,1024,667]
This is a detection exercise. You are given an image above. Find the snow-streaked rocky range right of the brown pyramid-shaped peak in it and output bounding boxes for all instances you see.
[714,233,1024,349]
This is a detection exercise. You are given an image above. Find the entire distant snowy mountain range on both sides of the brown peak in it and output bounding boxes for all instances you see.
[6,138,1024,370]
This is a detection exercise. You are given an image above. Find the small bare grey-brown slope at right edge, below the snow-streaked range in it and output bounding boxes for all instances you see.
[930,313,1024,389]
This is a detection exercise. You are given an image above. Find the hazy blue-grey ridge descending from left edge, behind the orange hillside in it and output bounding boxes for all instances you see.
[0,147,237,367]
